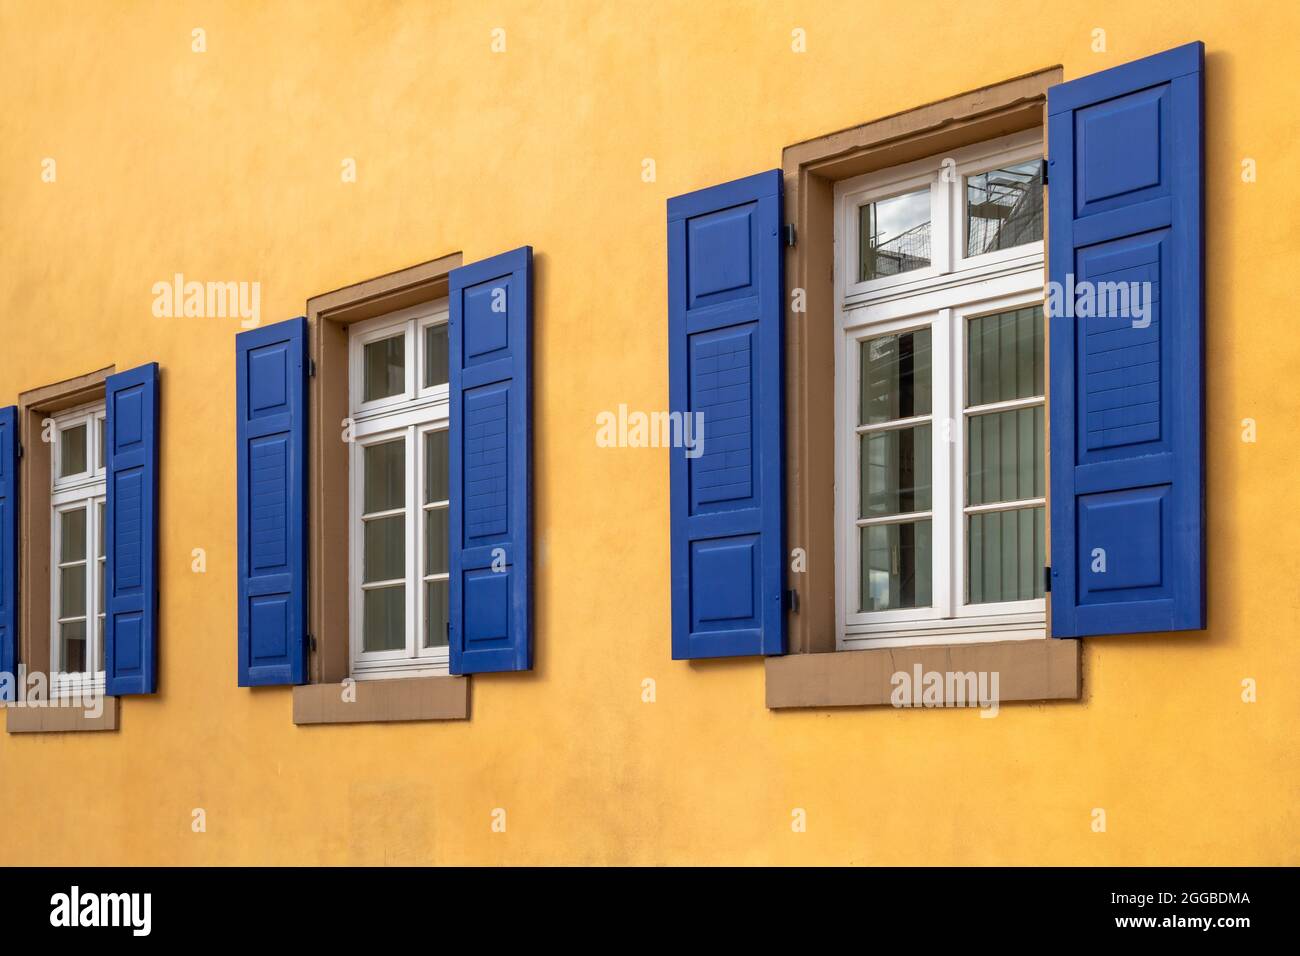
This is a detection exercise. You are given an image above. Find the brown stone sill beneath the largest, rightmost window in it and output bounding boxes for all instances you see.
[766,637,1083,710]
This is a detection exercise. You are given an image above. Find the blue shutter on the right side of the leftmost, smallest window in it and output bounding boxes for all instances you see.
[104,363,159,696]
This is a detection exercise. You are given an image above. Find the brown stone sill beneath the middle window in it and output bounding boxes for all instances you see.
[294,676,469,724]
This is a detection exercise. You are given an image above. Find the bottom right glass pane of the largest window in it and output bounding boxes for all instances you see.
[966,507,1047,604]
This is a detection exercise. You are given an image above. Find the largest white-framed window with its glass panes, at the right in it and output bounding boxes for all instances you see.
[836,130,1047,648]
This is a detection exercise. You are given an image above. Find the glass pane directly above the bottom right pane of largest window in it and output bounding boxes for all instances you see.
[966,405,1045,505]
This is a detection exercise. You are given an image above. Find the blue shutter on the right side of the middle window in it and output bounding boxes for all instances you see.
[447,246,533,674]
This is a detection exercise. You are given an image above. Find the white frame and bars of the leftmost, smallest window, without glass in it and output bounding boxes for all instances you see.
[49,402,108,697]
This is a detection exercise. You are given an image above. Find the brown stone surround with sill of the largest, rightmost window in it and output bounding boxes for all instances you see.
[767,66,1079,706]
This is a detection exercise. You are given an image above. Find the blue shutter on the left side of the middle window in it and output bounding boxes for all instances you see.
[235,317,308,687]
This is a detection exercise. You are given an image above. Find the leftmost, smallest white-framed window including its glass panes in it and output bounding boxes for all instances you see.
[49,403,105,695]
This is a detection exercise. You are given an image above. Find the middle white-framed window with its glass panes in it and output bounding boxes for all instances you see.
[348,299,450,678]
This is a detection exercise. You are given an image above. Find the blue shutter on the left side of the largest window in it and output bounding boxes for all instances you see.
[668,169,785,659]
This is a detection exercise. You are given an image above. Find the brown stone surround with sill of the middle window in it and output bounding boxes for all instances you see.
[294,252,469,723]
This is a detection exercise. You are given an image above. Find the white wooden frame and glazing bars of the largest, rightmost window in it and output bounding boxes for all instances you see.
[835,130,1047,649]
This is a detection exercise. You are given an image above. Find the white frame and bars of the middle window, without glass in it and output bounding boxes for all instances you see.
[348,299,450,680]
